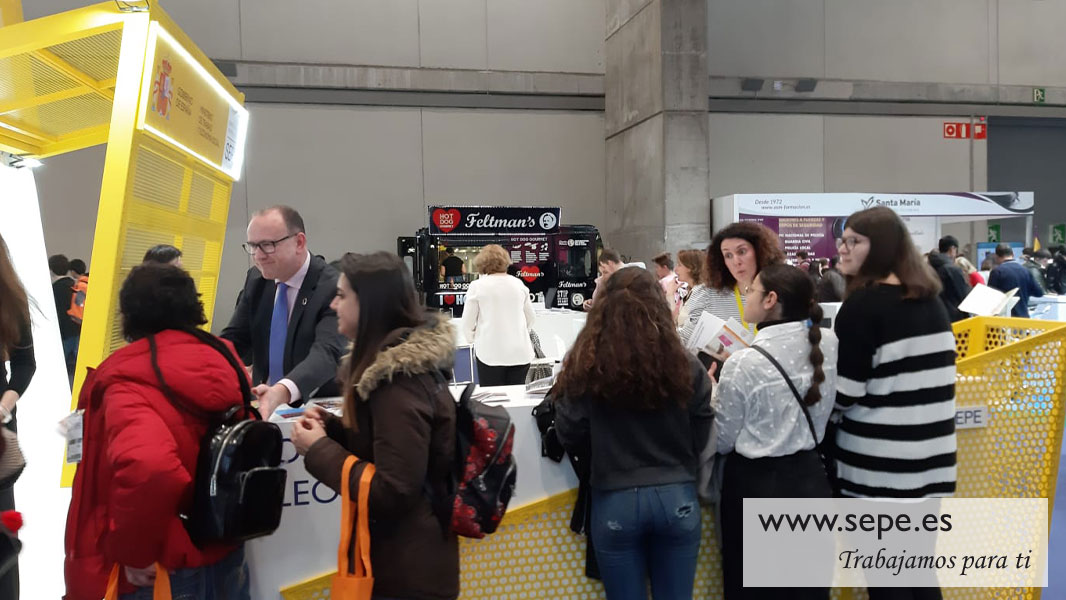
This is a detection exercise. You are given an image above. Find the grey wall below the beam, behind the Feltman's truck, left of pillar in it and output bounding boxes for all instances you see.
[36,104,604,326]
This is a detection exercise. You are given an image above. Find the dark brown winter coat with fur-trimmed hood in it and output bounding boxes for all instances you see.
[304,319,459,600]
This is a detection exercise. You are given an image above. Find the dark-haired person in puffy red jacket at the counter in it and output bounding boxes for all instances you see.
[64,265,249,600]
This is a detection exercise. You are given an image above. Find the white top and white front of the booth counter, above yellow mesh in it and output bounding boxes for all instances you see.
[245,386,578,600]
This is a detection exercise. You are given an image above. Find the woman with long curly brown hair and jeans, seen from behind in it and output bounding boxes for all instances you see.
[555,266,713,600]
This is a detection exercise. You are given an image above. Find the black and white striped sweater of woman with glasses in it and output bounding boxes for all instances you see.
[835,285,956,498]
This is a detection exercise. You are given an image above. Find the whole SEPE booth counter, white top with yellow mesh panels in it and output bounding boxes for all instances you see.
[257,318,1066,600]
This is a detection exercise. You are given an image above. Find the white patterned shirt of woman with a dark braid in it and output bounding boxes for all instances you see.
[711,322,838,458]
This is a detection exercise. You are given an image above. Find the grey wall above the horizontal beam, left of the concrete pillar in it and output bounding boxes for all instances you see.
[22,0,605,74]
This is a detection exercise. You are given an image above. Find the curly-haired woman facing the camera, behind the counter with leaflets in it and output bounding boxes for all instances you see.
[681,221,785,349]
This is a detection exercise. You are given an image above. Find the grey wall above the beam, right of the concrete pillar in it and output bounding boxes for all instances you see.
[708,0,1066,86]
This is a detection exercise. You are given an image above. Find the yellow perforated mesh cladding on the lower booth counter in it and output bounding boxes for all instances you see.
[281,318,1066,600]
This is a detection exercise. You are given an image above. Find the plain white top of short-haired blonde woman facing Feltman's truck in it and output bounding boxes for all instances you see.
[463,273,534,367]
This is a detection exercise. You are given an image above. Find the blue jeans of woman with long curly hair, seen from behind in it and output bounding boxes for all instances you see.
[591,483,700,600]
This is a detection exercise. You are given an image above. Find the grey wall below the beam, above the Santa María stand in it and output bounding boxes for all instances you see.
[709,113,988,197]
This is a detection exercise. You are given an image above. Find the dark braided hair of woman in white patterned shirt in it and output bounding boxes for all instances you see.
[759,263,825,406]
